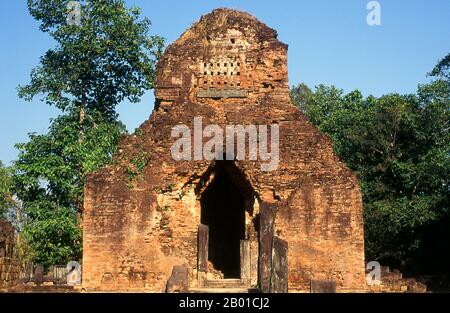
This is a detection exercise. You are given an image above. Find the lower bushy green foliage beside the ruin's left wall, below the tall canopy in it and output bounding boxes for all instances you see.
[14,113,125,265]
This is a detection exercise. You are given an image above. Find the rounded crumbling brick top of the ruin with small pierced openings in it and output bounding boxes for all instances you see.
[155,9,288,105]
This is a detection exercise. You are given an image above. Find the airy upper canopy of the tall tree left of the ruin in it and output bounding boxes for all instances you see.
[19,0,164,116]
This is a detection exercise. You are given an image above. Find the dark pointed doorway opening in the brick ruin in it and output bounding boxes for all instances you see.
[200,161,245,278]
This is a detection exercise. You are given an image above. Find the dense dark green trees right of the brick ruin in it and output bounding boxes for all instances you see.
[291,54,450,288]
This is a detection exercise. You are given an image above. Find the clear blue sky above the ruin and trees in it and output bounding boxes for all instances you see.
[0,0,450,163]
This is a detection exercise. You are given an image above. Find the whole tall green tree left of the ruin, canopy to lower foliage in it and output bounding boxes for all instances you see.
[14,0,163,265]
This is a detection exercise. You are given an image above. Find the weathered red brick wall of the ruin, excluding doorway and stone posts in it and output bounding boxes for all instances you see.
[83,9,364,291]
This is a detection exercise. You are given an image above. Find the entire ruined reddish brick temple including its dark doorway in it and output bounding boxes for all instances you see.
[83,9,365,292]
